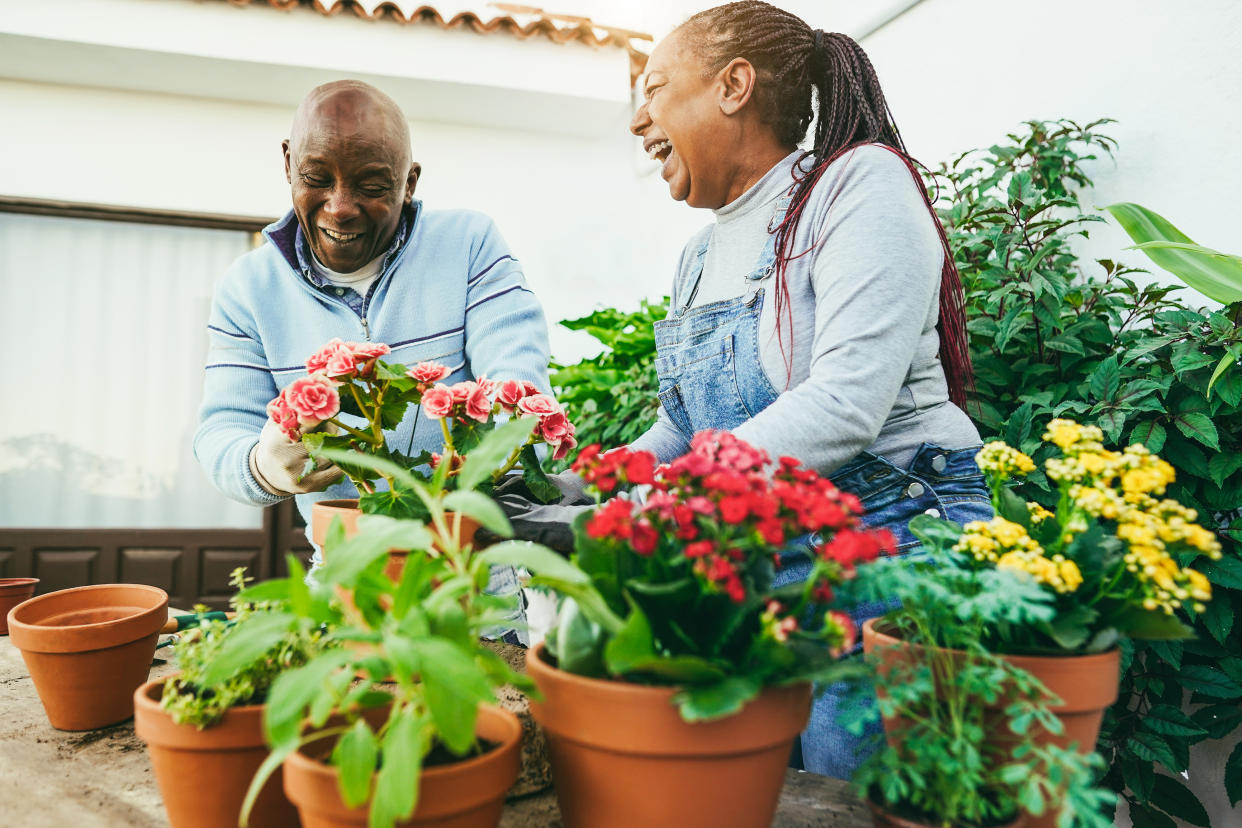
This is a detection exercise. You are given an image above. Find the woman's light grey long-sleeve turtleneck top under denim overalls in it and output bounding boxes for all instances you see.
[633,145,979,474]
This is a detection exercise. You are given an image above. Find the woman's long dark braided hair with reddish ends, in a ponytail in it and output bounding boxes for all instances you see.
[677,0,974,408]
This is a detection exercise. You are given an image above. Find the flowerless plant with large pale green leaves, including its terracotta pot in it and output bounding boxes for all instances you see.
[225,420,565,827]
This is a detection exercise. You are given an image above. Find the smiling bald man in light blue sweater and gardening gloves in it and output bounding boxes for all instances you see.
[194,81,548,620]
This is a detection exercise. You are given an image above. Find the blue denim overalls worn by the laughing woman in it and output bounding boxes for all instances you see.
[656,197,992,778]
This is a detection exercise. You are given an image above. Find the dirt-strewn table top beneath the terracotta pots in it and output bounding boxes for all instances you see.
[0,625,871,828]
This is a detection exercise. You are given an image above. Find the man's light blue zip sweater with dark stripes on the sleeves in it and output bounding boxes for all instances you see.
[194,201,549,520]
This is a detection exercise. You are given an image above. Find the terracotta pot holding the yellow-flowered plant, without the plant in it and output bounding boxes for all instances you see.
[862,618,1122,828]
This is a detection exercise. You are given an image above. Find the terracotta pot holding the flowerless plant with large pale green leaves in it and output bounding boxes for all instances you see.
[284,706,522,828]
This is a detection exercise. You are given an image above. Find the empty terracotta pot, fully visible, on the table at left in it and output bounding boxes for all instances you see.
[9,583,168,730]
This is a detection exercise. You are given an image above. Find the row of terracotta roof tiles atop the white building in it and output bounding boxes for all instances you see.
[219,0,653,82]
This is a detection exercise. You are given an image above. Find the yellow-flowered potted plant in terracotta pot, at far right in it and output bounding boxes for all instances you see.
[868,420,1221,824]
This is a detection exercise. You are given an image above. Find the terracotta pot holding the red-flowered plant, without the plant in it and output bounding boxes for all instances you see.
[527,644,811,828]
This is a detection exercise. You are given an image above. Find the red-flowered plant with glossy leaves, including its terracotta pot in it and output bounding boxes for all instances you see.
[527,432,892,828]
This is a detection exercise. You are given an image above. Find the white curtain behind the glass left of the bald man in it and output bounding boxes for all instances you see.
[0,214,262,529]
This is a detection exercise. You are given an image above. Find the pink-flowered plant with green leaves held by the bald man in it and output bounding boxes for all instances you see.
[267,339,578,556]
